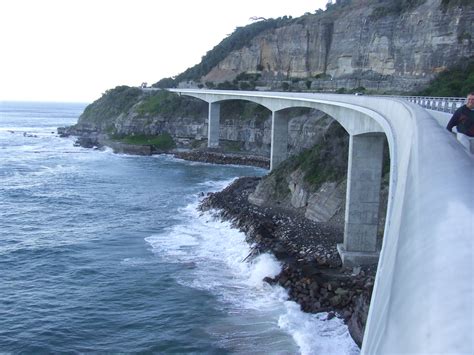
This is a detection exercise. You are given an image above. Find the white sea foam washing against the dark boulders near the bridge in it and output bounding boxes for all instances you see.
[146,197,359,355]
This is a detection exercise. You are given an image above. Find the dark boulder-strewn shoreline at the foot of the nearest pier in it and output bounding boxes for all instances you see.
[199,177,376,346]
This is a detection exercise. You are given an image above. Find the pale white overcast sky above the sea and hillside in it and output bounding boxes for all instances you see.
[0,0,327,102]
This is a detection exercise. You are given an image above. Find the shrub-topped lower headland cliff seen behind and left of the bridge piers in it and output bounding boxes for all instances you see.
[70,87,333,156]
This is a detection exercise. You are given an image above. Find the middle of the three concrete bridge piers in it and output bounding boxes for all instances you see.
[270,111,288,171]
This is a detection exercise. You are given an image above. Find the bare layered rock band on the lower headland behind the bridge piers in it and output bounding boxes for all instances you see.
[73,103,333,157]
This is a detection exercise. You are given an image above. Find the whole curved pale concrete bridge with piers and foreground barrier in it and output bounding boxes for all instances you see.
[166,89,474,354]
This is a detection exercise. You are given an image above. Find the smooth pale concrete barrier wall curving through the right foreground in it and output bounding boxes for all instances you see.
[362,98,474,354]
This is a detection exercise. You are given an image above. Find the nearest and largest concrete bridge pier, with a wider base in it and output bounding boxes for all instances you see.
[338,134,384,267]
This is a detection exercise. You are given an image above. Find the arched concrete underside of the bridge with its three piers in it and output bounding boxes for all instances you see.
[178,91,384,267]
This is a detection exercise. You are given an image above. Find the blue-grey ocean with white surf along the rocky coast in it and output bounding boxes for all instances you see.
[0,102,359,354]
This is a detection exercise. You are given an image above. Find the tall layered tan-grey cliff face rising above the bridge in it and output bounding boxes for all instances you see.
[201,0,474,91]
